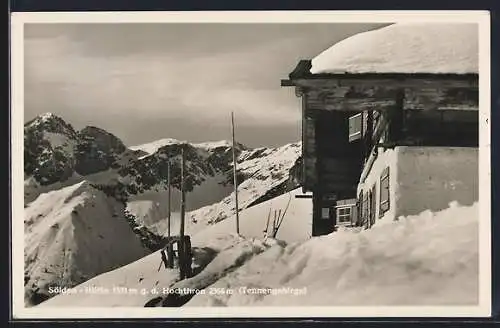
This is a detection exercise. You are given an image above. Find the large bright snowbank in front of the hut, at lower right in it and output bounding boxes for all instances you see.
[186,203,479,306]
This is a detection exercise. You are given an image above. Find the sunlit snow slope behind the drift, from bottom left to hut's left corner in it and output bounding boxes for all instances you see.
[38,190,312,306]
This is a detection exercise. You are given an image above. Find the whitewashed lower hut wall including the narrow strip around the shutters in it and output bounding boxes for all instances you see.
[358,146,479,224]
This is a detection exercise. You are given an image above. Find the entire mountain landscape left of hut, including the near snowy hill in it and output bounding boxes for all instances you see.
[24,114,301,303]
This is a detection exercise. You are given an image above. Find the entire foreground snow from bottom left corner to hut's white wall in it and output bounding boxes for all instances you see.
[40,200,479,306]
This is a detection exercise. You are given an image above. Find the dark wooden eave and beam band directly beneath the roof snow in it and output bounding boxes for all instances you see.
[281,60,479,112]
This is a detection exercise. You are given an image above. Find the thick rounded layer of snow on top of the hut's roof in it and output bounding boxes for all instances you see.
[310,23,479,74]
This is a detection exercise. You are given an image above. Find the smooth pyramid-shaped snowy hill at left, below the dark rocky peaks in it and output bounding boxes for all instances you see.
[24,181,148,303]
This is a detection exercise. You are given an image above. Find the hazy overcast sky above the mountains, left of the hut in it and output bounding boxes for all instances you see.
[24,23,379,146]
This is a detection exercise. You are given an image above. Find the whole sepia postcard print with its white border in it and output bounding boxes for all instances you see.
[11,12,491,318]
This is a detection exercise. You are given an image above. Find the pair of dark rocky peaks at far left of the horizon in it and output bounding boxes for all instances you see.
[24,113,135,186]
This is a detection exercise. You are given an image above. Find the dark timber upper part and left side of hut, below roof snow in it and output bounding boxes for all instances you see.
[281,60,479,236]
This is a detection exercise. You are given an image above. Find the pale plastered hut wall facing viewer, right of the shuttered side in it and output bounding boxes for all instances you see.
[395,147,479,216]
